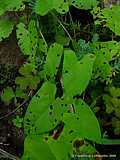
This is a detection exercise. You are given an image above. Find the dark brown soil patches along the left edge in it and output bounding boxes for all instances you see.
[0,31,24,159]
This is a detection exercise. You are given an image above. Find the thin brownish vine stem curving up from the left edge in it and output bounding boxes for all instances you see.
[0,91,32,120]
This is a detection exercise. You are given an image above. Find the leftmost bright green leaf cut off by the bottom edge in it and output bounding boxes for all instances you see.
[21,135,56,160]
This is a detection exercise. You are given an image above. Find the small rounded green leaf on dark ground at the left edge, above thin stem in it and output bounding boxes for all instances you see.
[1,87,15,104]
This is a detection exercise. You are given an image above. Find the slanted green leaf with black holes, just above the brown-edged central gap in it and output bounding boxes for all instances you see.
[34,99,68,134]
